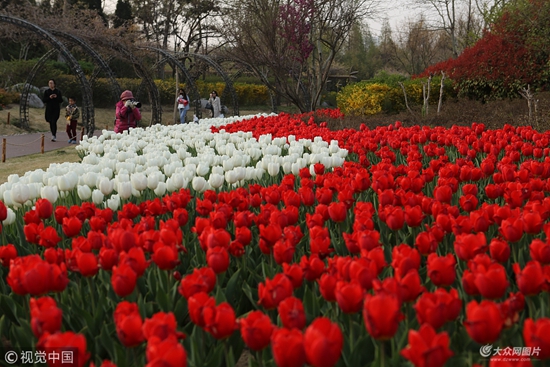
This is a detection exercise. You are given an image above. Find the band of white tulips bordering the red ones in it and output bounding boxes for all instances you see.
[0,116,348,224]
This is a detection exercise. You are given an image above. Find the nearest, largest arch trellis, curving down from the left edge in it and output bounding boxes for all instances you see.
[0,15,94,134]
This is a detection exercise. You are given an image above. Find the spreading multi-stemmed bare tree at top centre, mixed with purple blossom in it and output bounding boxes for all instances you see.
[224,0,378,111]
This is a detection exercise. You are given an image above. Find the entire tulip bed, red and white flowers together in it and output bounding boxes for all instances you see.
[0,110,550,367]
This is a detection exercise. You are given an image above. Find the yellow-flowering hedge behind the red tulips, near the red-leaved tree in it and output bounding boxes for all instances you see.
[336,77,456,116]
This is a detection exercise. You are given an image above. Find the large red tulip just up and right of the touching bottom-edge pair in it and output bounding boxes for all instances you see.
[363,293,404,340]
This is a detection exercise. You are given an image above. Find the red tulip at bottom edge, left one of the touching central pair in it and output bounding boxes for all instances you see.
[271,328,306,367]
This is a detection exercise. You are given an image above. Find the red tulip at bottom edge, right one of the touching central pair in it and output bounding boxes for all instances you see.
[304,317,344,367]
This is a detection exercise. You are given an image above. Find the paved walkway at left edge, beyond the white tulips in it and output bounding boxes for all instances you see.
[0,129,101,163]
